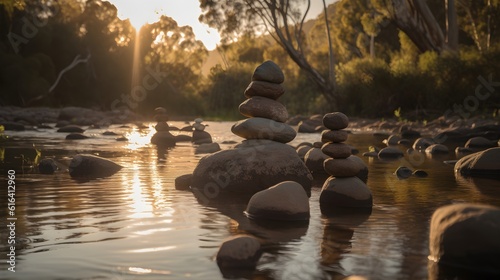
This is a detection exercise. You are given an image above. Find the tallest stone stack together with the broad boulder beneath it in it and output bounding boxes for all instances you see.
[191,61,313,199]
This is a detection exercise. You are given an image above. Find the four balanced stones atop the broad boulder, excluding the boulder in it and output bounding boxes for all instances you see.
[231,60,297,143]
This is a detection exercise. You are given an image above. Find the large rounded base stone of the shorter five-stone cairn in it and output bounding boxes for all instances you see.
[319,176,373,212]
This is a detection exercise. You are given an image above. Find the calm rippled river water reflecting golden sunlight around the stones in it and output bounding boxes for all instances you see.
[0,122,500,279]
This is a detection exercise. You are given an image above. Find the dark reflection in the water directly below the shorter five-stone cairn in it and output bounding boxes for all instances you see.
[321,211,371,278]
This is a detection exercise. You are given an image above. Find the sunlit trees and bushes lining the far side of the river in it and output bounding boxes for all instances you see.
[0,0,500,119]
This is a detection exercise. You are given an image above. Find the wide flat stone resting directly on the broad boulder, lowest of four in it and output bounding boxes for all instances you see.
[231,118,297,143]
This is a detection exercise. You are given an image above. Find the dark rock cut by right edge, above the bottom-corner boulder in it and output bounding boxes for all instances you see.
[455,147,500,178]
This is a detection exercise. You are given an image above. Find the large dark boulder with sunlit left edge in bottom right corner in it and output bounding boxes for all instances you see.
[429,203,500,279]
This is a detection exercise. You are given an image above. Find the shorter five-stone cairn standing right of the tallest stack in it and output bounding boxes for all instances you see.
[319,112,372,214]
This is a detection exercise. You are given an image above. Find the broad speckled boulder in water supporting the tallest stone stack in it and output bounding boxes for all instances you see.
[191,140,313,202]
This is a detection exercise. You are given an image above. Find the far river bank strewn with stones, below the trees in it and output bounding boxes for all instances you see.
[0,106,500,135]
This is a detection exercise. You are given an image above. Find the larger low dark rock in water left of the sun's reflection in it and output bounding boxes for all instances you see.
[69,154,122,179]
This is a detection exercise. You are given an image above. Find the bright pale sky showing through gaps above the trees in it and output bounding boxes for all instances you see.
[108,0,335,50]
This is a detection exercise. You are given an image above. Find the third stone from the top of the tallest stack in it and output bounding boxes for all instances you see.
[239,96,288,123]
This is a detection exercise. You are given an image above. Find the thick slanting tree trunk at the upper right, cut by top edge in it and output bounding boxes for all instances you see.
[392,0,446,53]
